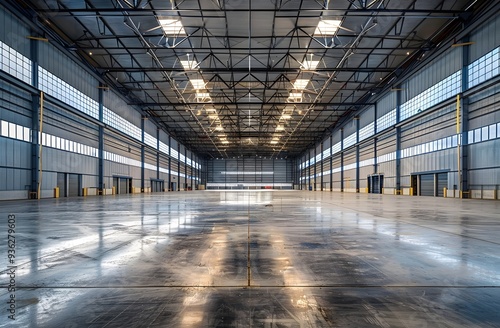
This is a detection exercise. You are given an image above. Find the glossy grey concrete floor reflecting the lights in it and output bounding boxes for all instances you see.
[0,191,500,327]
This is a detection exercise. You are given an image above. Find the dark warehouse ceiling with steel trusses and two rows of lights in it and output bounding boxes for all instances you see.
[7,0,484,158]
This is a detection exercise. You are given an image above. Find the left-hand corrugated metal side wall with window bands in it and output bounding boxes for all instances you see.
[0,6,203,200]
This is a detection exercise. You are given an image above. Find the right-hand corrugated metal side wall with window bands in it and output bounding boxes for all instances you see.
[296,12,500,199]
